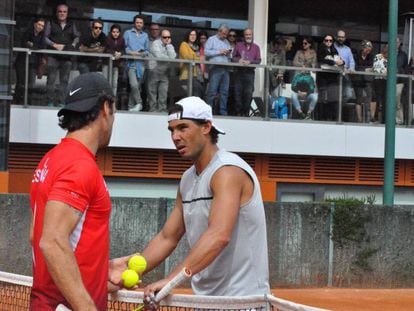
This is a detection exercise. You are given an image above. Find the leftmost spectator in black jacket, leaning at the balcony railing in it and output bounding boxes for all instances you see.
[14,17,46,104]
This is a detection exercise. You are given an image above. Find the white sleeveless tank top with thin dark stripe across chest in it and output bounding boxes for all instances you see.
[180,149,270,296]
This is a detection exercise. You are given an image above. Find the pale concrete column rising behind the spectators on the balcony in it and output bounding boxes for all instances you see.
[249,0,269,97]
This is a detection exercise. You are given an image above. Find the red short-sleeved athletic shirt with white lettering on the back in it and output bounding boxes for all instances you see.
[30,138,111,310]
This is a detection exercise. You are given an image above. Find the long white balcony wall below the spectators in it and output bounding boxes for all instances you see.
[10,106,414,159]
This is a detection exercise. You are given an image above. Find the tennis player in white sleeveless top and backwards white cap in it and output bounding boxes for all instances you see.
[108,97,270,296]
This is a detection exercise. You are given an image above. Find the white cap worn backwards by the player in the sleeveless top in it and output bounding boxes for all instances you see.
[168,96,226,134]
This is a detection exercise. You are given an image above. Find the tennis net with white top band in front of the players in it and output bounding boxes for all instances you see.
[0,271,326,311]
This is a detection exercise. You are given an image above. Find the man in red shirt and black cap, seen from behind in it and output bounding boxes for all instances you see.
[30,73,116,311]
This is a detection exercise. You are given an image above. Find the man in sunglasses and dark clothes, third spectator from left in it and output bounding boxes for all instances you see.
[78,19,106,74]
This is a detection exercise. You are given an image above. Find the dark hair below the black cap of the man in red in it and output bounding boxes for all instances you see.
[59,95,115,132]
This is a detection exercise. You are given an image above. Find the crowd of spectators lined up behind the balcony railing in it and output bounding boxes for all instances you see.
[15,4,413,124]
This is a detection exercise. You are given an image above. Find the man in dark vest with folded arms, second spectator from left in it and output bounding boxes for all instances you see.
[45,4,80,106]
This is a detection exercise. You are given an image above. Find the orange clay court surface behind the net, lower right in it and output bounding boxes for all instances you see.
[176,288,414,311]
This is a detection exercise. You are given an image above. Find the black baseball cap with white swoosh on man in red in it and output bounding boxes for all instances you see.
[58,72,114,117]
